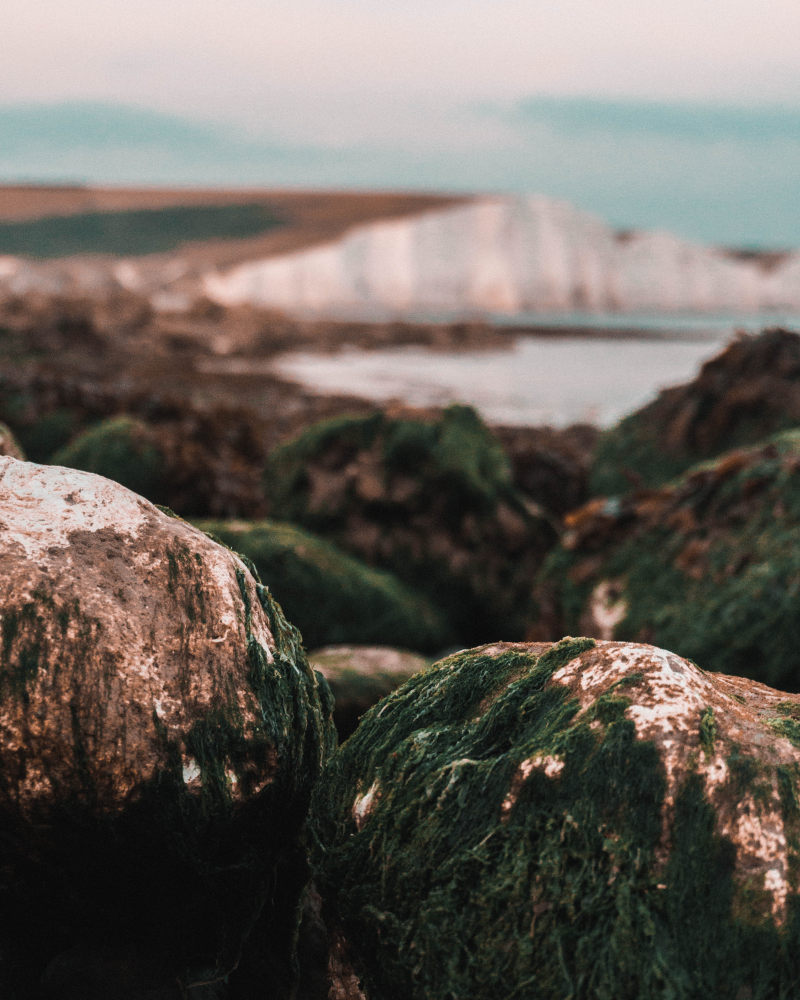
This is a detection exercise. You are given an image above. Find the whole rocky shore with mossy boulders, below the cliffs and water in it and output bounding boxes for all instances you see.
[0,296,800,1000]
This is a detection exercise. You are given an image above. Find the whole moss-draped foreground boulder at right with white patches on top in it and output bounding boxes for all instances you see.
[312,639,800,1000]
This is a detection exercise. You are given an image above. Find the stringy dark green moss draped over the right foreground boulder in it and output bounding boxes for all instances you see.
[312,640,800,1000]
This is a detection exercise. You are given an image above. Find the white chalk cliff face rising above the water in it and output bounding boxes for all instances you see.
[204,196,800,316]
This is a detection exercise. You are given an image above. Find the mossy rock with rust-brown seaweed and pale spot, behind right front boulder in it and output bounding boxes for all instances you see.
[531,431,800,691]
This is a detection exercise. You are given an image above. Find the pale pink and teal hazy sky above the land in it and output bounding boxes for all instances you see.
[0,0,800,245]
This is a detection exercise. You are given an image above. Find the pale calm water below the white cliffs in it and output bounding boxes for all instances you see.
[275,316,800,427]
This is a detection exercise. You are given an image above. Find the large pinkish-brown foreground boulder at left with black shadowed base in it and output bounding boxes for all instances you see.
[0,458,332,998]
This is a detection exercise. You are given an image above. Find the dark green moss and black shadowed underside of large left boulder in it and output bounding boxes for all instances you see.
[0,538,335,1000]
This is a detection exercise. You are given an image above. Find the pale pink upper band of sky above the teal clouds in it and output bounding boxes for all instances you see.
[0,0,800,135]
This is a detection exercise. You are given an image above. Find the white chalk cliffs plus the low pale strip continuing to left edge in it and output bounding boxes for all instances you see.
[0,195,800,319]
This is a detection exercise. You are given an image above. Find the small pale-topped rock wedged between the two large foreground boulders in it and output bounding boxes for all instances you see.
[308,646,430,743]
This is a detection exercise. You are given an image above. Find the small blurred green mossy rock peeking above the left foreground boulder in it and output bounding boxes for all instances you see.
[52,416,168,503]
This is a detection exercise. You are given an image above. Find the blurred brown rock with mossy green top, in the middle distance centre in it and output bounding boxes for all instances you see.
[264,406,556,642]
